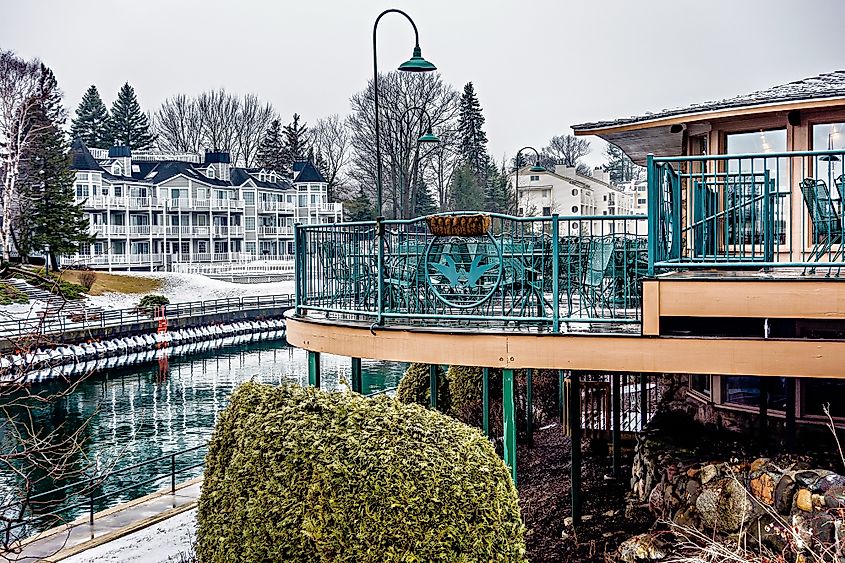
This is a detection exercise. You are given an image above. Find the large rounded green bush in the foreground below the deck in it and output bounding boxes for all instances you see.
[197,383,526,563]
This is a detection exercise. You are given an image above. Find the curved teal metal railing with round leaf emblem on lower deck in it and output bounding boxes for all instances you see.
[295,213,648,332]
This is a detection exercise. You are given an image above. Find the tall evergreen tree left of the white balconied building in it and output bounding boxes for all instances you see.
[14,65,90,268]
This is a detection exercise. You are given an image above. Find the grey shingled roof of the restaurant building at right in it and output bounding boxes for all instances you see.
[572,70,845,134]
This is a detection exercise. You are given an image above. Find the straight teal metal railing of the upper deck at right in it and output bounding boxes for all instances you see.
[647,149,845,274]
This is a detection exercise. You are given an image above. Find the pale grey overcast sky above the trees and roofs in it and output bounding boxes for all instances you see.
[0,0,845,164]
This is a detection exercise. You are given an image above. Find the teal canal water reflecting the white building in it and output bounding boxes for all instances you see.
[0,339,405,537]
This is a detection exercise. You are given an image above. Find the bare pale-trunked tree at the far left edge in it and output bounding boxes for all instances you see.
[0,51,41,260]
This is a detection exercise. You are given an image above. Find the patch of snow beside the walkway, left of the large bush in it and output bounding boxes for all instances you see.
[62,509,197,563]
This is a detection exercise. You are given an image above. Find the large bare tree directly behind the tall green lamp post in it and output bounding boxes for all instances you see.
[349,72,459,217]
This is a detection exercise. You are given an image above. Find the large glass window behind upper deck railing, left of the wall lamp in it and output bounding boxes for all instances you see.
[716,129,789,244]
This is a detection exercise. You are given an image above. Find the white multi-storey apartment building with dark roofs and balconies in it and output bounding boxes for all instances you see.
[64,140,343,270]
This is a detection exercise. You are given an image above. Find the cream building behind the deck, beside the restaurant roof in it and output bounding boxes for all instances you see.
[510,165,645,231]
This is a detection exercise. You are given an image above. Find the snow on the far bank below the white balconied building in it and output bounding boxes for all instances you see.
[88,272,293,309]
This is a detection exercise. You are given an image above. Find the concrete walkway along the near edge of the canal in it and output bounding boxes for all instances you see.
[10,477,202,562]
